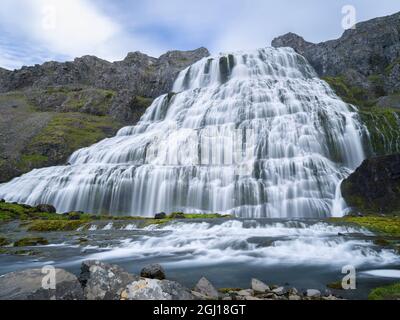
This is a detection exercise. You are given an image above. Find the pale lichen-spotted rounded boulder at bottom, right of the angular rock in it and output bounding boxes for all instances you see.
[120,279,195,300]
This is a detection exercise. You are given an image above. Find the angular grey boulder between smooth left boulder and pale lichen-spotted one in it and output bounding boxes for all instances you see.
[79,261,139,300]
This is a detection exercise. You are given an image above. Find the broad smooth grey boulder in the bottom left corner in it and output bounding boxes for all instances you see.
[0,269,84,300]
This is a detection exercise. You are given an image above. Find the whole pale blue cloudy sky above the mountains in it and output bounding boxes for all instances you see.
[0,0,400,69]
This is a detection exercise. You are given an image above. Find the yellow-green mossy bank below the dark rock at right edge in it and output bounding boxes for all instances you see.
[330,216,400,237]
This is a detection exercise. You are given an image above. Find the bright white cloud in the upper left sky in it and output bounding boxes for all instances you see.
[0,0,162,66]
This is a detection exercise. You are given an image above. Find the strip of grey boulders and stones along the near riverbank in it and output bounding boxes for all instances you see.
[0,261,340,301]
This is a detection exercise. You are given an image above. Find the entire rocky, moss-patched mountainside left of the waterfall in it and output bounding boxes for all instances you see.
[0,48,209,183]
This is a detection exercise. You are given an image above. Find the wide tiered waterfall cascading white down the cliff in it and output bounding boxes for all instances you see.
[0,48,364,218]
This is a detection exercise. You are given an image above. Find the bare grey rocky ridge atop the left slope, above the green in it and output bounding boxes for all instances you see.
[0,48,209,98]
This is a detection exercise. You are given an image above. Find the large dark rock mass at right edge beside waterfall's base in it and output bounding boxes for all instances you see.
[342,154,400,214]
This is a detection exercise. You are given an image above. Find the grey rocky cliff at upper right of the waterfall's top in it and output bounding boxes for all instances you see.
[272,13,400,97]
